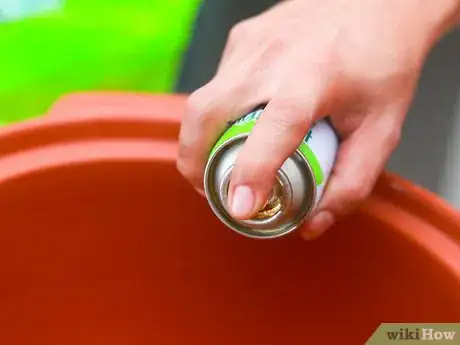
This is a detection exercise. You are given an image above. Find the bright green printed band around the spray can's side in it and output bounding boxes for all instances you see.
[210,109,324,186]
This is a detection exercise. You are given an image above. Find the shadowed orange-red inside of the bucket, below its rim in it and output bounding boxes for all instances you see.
[0,160,460,345]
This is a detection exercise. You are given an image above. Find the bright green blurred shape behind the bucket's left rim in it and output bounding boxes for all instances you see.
[0,0,200,123]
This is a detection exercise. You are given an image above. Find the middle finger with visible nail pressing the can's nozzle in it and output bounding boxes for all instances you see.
[228,93,328,219]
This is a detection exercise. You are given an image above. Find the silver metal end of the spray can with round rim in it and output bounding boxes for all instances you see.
[204,136,316,238]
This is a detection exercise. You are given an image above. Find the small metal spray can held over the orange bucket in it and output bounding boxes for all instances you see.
[204,108,339,238]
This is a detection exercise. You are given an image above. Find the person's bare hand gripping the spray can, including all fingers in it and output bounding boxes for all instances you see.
[177,0,460,239]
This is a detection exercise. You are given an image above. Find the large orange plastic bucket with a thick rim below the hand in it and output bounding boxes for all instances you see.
[0,94,460,345]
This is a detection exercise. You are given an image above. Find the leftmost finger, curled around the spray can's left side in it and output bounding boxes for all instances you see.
[177,81,255,195]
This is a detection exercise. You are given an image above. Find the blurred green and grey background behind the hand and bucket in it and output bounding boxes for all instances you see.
[0,0,460,208]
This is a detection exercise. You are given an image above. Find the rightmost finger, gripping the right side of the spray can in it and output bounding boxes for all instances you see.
[302,109,401,239]
